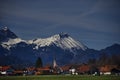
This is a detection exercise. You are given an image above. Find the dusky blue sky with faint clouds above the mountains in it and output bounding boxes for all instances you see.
[0,0,120,50]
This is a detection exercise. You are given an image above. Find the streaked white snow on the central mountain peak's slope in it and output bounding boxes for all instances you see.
[28,33,87,50]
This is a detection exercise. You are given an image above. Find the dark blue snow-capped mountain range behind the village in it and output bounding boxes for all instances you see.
[0,27,120,66]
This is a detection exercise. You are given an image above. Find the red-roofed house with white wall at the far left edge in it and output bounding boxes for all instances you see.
[0,66,14,75]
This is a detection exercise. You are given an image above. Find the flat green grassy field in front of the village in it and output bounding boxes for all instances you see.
[0,75,120,80]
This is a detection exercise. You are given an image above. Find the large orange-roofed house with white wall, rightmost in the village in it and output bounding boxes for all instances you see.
[99,65,116,75]
